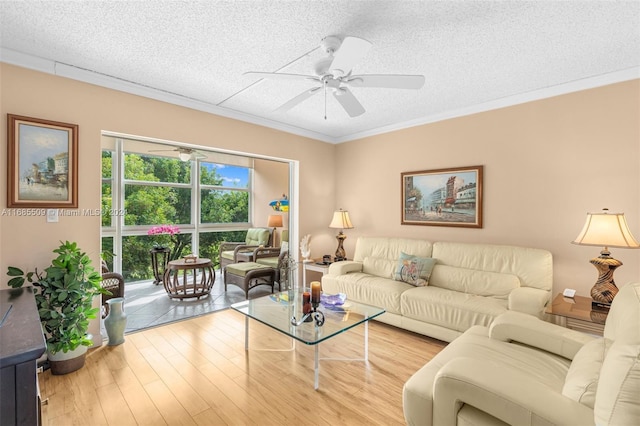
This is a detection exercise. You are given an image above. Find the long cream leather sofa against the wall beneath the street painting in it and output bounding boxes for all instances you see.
[322,237,553,342]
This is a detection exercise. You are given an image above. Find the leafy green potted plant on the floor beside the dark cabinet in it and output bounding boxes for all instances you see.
[7,241,110,374]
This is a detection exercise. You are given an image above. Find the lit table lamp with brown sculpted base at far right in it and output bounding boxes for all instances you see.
[572,209,640,309]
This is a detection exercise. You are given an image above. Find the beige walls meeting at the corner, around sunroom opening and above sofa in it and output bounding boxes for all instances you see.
[0,63,640,310]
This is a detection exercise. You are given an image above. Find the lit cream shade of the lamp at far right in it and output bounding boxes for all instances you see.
[573,212,640,248]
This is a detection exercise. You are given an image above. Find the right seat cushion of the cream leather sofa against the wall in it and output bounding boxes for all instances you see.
[402,285,507,331]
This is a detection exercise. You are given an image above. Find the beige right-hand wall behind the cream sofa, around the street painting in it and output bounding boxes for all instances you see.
[336,80,640,295]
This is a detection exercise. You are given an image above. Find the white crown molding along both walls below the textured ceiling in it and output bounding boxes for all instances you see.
[0,48,640,144]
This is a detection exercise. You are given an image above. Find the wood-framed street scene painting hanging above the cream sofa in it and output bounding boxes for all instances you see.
[401,166,483,228]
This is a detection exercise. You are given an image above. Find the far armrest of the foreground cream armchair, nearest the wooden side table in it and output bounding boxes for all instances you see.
[489,312,595,359]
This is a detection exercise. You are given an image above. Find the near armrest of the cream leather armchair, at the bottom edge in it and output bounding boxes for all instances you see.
[433,357,594,425]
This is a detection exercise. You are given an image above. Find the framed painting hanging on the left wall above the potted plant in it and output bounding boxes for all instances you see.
[7,114,78,208]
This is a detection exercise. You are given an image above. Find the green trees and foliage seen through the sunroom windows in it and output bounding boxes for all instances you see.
[102,151,250,281]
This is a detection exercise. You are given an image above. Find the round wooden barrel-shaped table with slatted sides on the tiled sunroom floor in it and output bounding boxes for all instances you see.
[163,258,216,299]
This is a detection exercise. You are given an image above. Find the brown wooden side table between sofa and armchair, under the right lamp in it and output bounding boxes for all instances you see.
[546,293,609,336]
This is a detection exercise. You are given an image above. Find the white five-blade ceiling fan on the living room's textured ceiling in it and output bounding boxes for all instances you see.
[244,36,425,120]
